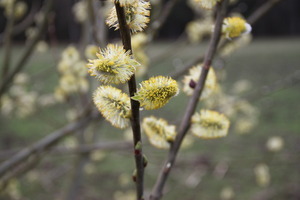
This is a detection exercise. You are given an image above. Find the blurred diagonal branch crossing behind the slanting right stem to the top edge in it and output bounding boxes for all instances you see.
[170,0,282,79]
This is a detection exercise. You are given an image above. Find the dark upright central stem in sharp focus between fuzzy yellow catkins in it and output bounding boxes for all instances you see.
[115,1,144,200]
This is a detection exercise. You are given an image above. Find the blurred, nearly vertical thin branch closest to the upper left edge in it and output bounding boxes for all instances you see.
[2,1,16,78]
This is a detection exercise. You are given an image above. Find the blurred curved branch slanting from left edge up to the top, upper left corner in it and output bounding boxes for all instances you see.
[0,0,53,98]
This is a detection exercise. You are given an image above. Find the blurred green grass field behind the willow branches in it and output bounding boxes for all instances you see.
[0,38,300,200]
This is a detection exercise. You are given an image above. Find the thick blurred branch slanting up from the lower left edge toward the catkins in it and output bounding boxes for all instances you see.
[0,109,99,180]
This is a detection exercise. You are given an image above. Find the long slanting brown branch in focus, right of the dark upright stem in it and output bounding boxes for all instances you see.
[150,0,228,200]
